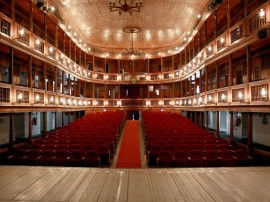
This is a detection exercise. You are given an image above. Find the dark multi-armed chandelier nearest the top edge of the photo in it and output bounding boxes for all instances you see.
[109,0,142,16]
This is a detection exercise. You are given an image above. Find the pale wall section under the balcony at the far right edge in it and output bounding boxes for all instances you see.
[252,113,270,146]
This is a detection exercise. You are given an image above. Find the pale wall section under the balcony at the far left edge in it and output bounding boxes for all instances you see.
[0,114,10,145]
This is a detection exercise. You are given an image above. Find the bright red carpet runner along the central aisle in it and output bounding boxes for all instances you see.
[116,121,141,168]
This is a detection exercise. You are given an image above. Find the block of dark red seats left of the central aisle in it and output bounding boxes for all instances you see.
[8,111,124,167]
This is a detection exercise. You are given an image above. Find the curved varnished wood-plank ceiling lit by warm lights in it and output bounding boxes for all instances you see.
[49,0,211,55]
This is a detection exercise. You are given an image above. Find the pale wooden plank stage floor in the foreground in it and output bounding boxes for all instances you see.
[0,166,270,202]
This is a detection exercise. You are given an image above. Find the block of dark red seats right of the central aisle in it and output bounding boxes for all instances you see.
[142,111,252,167]
